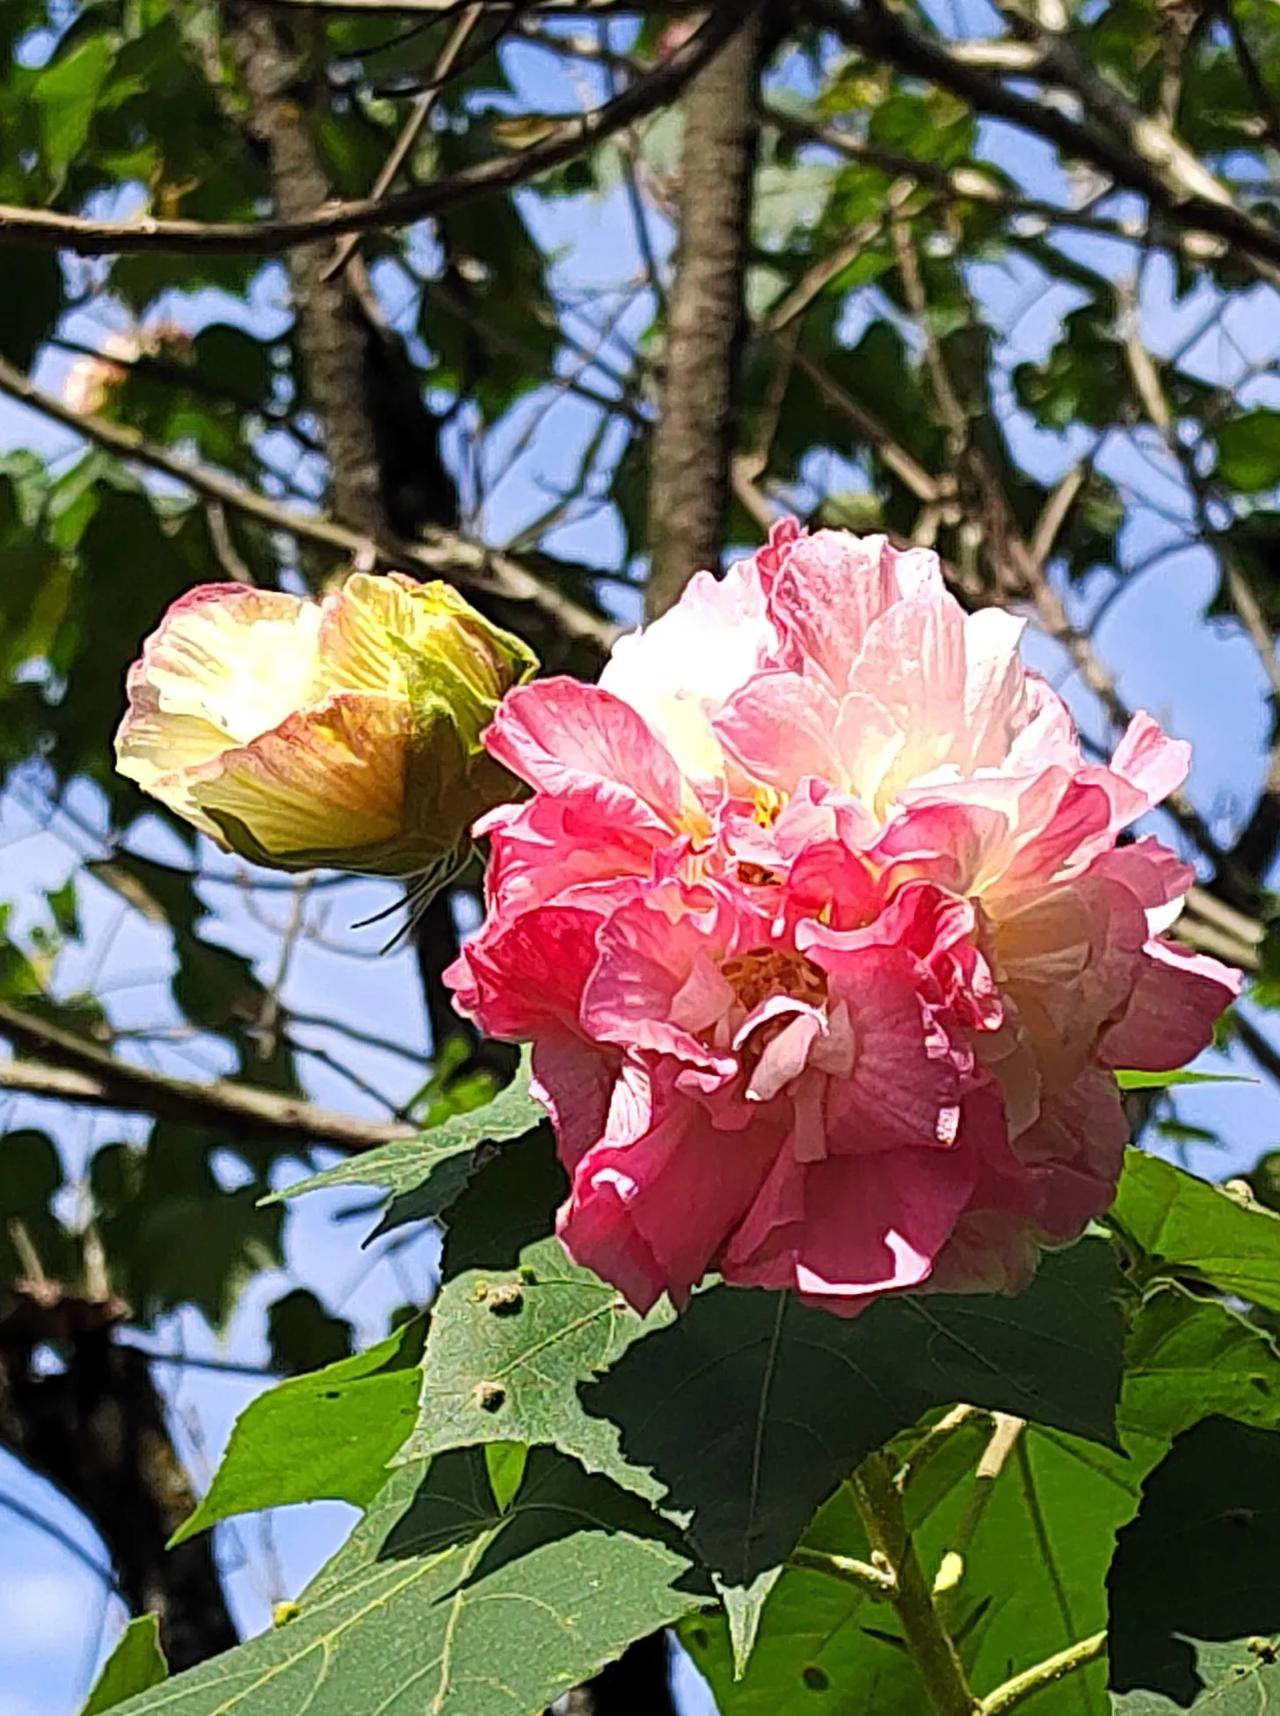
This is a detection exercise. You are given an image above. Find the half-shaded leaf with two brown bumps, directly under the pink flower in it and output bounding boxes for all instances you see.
[405,1150,1122,1586]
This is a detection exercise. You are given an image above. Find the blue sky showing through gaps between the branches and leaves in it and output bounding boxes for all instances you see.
[0,3,1280,1716]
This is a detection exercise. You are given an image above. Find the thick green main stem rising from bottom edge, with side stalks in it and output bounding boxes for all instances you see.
[849,1453,980,1716]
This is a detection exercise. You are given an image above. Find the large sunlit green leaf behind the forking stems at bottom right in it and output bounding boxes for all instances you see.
[681,1285,1280,1716]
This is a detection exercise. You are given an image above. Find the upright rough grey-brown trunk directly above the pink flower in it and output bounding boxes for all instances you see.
[649,5,765,616]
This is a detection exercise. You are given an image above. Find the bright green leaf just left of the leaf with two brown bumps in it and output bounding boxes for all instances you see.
[173,1321,422,1543]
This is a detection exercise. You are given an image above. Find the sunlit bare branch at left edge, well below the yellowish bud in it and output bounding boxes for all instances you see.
[0,1002,414,1150]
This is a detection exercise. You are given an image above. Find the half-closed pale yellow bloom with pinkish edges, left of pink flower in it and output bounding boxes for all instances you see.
[115,573,537,875]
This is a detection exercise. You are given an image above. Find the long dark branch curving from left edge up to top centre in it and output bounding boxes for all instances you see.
[0,0,748,256]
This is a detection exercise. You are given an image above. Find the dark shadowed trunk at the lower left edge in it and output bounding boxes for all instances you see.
[0,1284,237,1671]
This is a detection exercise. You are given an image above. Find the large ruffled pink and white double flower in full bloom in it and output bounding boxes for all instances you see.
[450,522,1237,1313]
